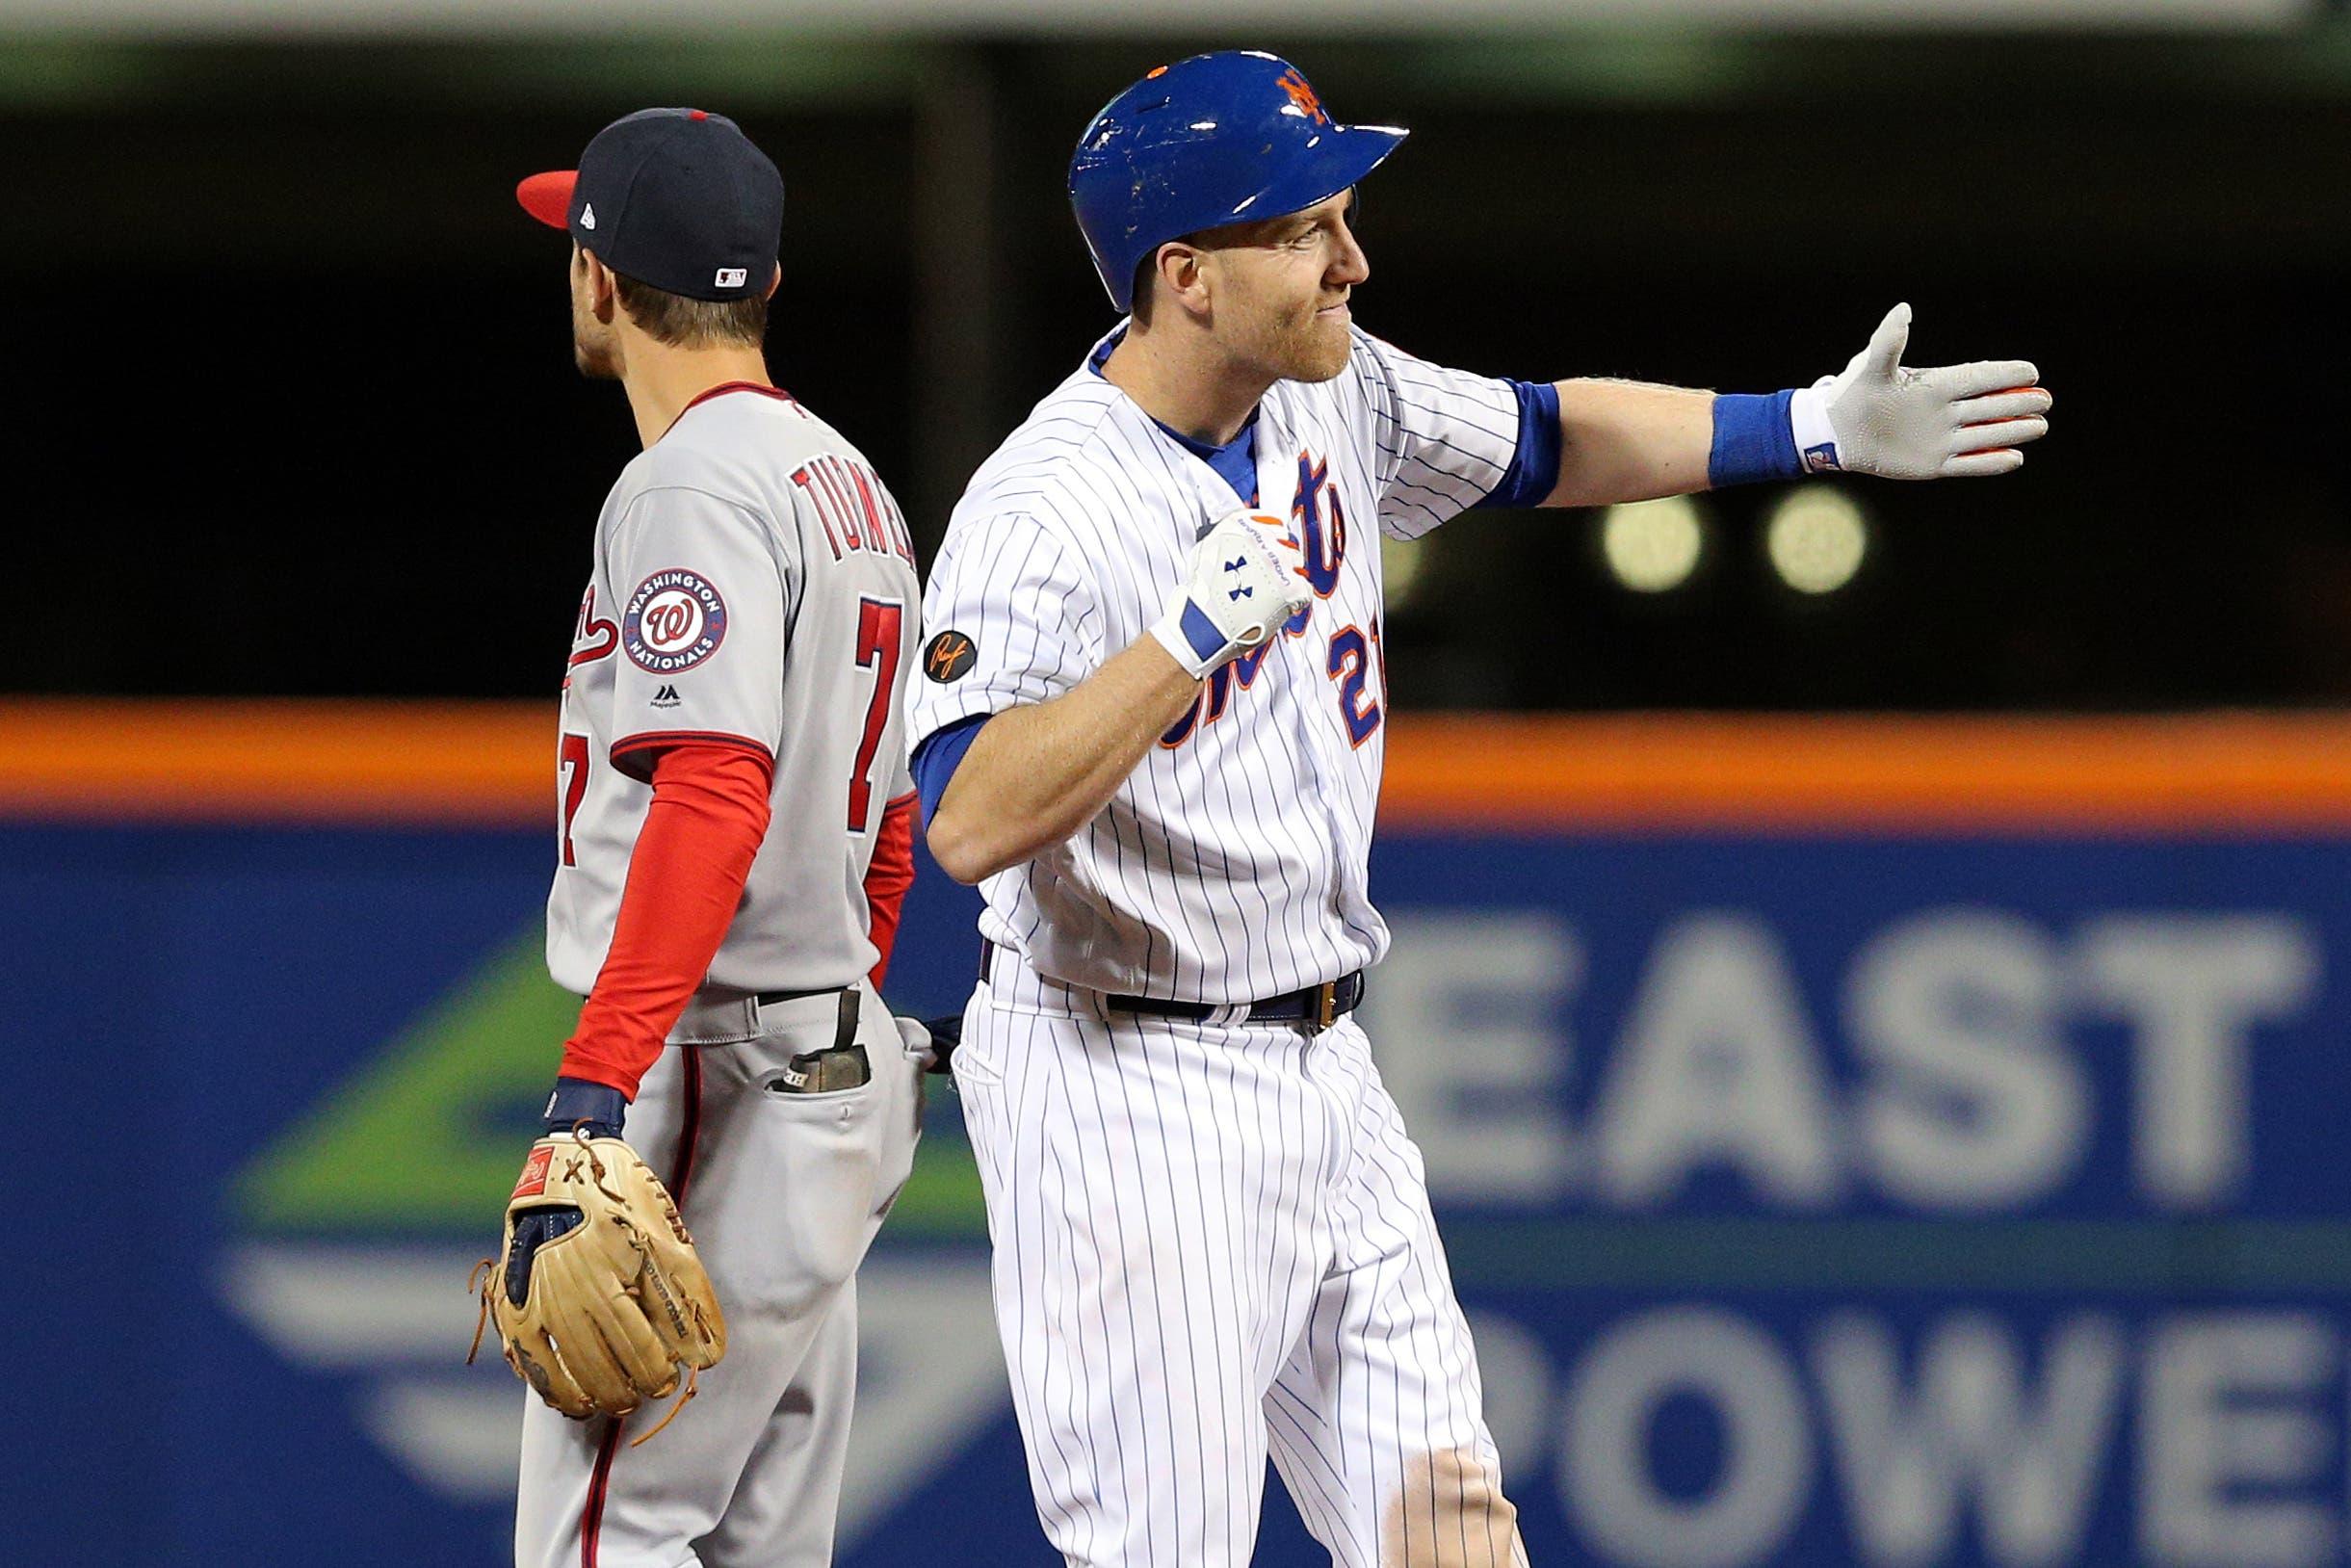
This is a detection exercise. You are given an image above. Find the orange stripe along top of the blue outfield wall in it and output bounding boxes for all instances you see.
[0,700,2351,832]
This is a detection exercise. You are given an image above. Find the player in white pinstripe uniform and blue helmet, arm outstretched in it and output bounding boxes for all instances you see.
[910,54,2051,1568]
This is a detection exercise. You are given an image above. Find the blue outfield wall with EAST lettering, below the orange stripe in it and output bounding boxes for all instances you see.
[0,823,2351,1568]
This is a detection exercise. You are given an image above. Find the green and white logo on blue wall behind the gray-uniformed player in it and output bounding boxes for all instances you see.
[221,928,1004,1537]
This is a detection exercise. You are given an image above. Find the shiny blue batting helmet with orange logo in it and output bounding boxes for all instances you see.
[1070,49,1406,310]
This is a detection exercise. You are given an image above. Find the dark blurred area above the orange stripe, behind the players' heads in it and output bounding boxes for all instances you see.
[18,11,2351,710]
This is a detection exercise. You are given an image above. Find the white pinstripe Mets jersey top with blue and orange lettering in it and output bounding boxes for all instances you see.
[910,327,1519,1004]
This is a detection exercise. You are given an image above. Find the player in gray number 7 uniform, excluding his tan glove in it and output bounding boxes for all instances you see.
[503,108,924,1568]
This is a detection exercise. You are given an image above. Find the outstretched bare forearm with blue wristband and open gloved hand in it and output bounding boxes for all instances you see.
[1545,305,2051,506]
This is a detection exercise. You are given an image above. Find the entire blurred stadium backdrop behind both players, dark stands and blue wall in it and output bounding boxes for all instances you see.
[18,12,2351,1568]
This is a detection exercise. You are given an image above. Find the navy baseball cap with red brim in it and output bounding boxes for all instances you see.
[515,108,783,301]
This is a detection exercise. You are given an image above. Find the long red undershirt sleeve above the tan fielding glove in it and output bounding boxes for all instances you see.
[562,743,771,1100]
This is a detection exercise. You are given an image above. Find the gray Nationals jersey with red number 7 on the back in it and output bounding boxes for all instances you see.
[548,383,922,994]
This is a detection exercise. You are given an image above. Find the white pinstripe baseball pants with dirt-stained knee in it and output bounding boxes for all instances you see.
[954,959,1526,1568]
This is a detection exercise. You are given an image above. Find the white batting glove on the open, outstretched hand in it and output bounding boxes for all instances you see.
[1789,305,2051,480]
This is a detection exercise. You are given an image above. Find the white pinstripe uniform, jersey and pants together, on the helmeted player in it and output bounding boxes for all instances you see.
[926,324,1524,1568]
